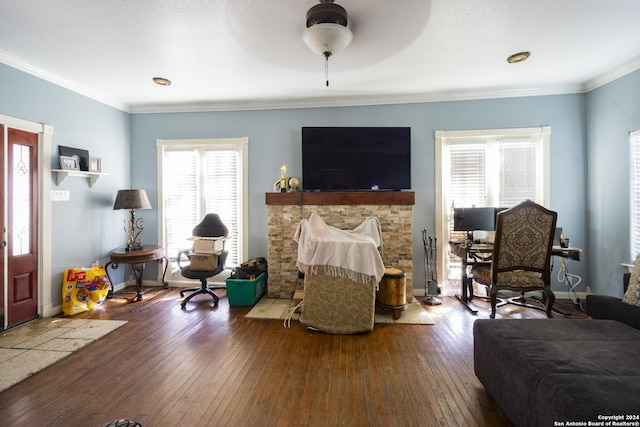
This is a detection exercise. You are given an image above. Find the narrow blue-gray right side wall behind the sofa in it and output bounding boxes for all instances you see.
[585,70,640,296]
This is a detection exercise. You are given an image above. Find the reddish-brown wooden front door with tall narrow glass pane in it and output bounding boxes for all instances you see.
[3,129,38,326]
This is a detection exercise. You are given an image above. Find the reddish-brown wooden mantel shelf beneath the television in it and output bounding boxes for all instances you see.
[265,191,415,206]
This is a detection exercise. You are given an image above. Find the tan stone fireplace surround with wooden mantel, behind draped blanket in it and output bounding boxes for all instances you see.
[265,191,415,299]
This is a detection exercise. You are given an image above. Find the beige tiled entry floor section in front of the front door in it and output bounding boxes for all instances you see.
[0,317,127,392]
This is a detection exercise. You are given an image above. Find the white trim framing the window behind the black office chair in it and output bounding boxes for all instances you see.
[156,137,249,284]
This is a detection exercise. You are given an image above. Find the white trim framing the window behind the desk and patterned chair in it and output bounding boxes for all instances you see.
[435,126,551,283]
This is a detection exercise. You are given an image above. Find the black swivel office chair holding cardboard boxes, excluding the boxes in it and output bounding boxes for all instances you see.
[178,213,229,308]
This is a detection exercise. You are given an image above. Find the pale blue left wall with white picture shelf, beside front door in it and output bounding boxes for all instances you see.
[0,64,131,307]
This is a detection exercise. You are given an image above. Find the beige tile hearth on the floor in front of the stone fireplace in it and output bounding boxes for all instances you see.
[246,297,435,325]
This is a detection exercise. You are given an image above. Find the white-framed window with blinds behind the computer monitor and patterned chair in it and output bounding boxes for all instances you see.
[436,126,551,288]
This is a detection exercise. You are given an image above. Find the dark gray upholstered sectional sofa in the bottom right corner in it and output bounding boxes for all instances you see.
[473,295,640,427]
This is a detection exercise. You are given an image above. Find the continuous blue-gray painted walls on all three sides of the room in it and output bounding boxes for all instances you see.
[0,64,640,306]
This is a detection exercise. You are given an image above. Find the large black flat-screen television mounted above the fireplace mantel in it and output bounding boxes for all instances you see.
[302,127,411,191]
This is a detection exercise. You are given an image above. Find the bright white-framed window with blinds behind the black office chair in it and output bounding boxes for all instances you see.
[156,138,248,278]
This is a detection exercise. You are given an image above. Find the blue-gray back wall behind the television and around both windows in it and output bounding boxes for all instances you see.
[131,95,588,291]
